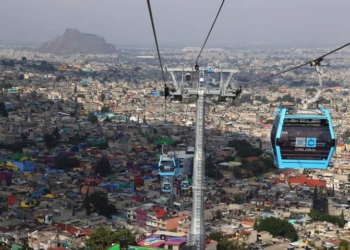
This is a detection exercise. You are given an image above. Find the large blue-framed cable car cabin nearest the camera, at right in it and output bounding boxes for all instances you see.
[271,107,336,169]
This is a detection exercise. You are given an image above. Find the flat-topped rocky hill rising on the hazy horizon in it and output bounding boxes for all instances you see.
[38,29,115,54]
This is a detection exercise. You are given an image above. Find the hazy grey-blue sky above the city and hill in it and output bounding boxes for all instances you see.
[0,0,350,47]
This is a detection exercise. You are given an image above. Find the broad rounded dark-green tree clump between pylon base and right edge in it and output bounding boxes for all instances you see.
[254,217,298,241]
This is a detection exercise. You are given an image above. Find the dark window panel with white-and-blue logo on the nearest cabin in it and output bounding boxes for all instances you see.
[278,119,334,160]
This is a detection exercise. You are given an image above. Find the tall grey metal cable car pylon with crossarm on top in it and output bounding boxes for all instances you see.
[167,65,242,250]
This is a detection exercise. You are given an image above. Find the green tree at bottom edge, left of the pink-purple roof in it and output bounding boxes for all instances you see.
[85,227,136,250]
